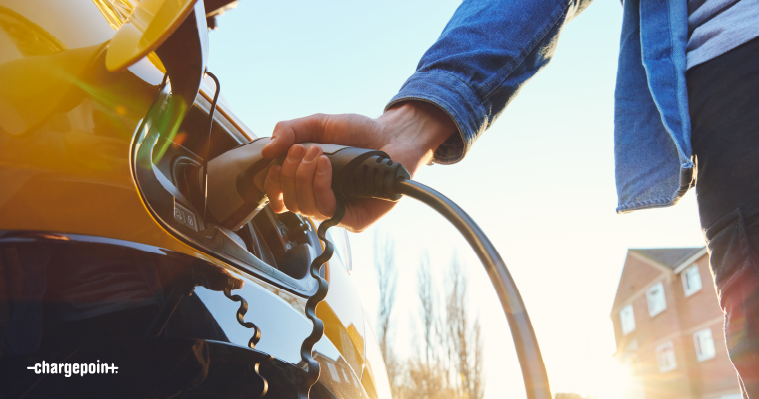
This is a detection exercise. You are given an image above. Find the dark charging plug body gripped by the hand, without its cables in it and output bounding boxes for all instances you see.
[205,137,411,231]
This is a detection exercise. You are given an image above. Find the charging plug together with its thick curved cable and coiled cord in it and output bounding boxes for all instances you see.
[207,138,551,399]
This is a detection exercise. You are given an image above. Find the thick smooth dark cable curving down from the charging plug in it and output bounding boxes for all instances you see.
[394,178,551,399]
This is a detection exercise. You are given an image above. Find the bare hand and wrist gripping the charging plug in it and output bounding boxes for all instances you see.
[263,101,457,232]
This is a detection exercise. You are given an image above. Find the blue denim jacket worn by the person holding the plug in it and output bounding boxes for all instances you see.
[387,0,693,213]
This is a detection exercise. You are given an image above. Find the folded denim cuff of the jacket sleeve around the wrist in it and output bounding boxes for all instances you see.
[385,70,487,164]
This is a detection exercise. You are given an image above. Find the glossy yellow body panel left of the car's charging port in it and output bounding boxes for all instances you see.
[0,1,196,255]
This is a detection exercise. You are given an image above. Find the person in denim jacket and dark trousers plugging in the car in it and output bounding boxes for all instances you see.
[264,0,759,398]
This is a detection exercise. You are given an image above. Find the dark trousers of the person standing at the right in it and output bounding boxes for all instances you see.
[687,39,759,399]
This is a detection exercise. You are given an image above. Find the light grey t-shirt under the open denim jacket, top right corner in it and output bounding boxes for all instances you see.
[686,0,759,69]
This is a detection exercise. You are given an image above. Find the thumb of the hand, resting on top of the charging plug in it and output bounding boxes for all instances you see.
[262,114,329,159]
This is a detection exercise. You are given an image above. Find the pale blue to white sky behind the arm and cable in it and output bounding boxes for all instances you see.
[209,0,704,398]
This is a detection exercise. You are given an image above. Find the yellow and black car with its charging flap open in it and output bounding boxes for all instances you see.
[0,0,390,398]
